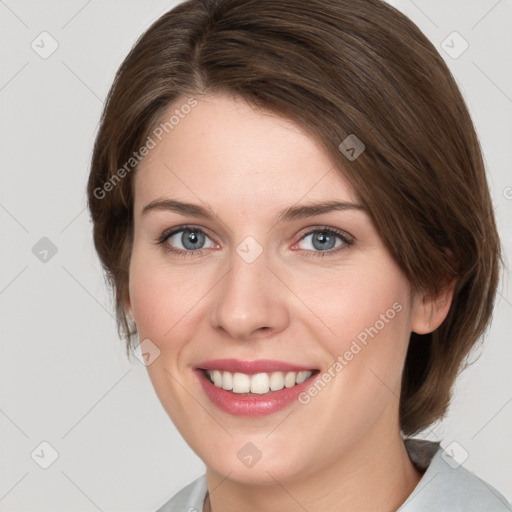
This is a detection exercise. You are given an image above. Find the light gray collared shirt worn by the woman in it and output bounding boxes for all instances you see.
[156,439,512,512]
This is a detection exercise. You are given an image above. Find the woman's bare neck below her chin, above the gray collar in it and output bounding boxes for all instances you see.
[204,424,422,512]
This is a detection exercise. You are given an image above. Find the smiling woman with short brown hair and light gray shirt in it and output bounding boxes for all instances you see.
[88,0,512,512]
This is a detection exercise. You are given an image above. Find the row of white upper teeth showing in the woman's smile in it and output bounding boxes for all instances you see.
[206,370,313,395]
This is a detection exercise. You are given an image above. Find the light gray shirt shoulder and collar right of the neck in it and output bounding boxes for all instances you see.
[397,440,512,512]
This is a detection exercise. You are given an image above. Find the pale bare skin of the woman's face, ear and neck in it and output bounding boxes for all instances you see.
[126,95,453,512]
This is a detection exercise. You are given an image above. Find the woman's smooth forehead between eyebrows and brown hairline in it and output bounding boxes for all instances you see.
[134,95,358,212]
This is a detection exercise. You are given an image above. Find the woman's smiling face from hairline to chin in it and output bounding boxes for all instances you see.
[128,96,428,483]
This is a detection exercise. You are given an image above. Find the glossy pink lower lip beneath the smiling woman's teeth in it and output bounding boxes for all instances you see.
[194,369,320,417]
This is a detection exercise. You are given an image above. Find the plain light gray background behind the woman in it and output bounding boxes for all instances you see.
[0,0,512,512]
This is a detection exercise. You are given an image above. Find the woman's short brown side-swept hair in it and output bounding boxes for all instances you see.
[88,0,501,435]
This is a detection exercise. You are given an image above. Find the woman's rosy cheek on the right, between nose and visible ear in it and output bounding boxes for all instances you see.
[294,254,410,410]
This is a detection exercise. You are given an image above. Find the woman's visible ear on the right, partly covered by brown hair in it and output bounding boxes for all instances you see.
[411,278,457,334]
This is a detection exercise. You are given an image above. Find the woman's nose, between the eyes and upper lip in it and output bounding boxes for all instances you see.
[211,243,290,340]
